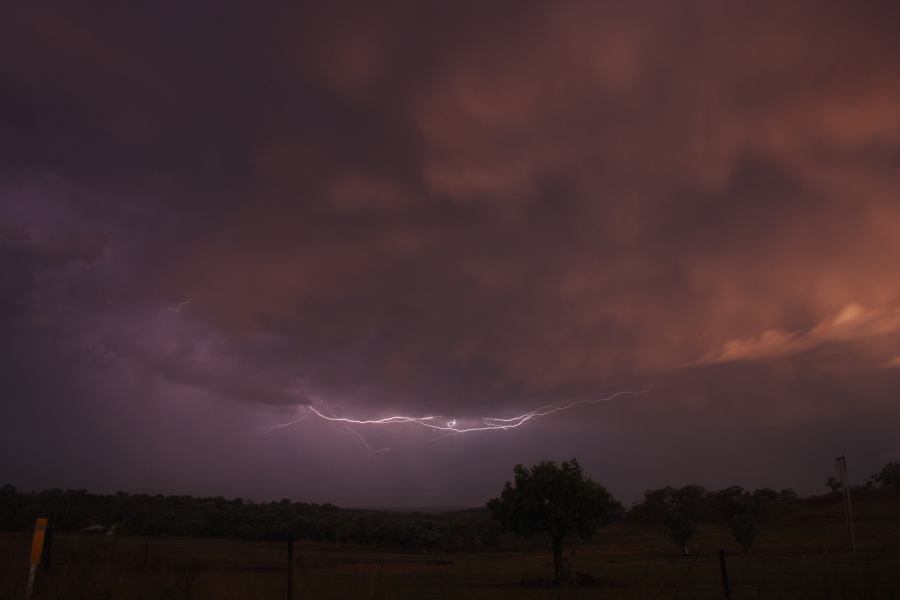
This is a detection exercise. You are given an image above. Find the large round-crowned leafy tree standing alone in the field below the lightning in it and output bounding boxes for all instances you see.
[487,458,622,583]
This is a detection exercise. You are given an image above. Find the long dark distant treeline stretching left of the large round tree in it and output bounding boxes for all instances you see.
[0,484,499,551]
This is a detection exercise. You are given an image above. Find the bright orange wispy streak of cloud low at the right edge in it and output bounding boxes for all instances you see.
[697,303,900,366]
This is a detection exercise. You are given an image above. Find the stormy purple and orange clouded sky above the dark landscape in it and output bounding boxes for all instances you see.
[0,0,900,506]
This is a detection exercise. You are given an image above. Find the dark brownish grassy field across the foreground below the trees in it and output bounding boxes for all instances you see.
[0,491,900,600]
